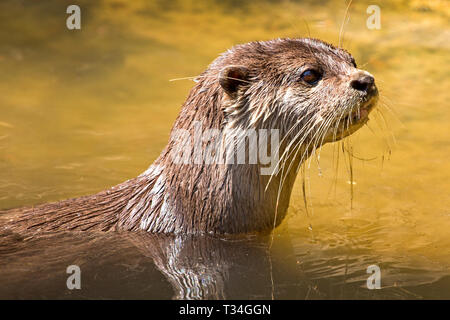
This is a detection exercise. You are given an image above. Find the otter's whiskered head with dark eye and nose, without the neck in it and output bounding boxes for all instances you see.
[216,39,378,152]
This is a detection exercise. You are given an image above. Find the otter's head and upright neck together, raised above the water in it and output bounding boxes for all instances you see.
[133,39,378,233]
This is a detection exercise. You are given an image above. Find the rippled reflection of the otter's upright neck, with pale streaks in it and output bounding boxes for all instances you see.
[126,233,297,299]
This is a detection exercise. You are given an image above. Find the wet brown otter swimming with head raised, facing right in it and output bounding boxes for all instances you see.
[0,38,378,234]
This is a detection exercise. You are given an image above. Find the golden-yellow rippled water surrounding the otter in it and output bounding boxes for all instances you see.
[0,0,450,299]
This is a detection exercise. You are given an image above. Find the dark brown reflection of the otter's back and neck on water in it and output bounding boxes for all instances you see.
[0,232,307,299]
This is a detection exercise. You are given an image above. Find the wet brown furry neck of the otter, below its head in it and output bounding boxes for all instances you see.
[119,80,312,234]
